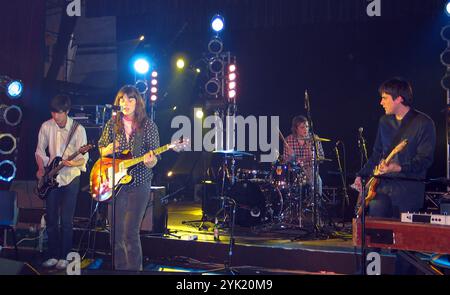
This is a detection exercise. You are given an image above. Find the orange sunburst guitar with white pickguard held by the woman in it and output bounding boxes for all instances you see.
[89,139,189,202]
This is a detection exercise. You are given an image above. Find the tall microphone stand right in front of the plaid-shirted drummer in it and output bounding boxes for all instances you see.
[305,90,319,237]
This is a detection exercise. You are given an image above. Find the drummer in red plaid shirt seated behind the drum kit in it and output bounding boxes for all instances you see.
[283,116,324,195]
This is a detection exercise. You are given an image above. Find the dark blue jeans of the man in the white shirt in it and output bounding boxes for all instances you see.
[46,176,80,259]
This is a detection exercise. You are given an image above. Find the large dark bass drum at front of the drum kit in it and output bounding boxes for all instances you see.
[230,180,283,227]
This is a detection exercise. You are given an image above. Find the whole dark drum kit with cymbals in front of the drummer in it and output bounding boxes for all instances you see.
[210,151,330,234]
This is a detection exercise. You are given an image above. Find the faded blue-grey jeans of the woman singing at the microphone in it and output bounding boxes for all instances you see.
[114,184,151,271]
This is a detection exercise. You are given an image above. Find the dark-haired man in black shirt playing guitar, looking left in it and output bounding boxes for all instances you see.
[352,78,436,274]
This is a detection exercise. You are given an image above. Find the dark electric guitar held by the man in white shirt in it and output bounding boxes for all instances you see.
[35,144,94,200]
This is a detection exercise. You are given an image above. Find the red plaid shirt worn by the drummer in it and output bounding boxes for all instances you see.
[283,134,324,183]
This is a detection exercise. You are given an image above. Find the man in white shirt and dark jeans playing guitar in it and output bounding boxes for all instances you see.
[35,95,89,270]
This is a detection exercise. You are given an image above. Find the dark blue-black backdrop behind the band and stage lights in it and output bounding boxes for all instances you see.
[0,0,450,192]
